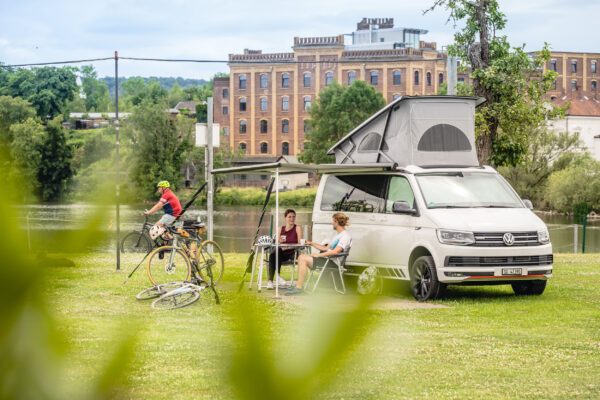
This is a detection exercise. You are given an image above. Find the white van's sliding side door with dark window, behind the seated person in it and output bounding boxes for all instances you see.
[313,174,388,265]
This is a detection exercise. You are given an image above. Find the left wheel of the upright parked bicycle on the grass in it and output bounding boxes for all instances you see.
[146,246,192,286]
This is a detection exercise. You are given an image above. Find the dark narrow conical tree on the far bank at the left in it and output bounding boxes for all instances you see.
[37,117,73,201]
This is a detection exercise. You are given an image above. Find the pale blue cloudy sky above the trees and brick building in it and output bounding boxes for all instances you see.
[0,0,600,79]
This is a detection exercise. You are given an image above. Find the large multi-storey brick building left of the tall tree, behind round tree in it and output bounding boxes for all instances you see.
[214,18,446,158]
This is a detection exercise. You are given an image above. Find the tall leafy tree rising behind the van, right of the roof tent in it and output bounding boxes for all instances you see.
[425,0,559,166]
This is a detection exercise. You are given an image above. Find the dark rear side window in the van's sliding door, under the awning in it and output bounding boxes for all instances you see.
[321,175,388,213]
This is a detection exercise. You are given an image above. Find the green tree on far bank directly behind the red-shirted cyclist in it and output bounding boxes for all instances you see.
[126,99,194,199]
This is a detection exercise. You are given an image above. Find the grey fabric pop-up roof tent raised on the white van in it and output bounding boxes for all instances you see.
[328,96,484,167]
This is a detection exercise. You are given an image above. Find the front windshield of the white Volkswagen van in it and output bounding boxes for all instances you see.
[416,172,523,208]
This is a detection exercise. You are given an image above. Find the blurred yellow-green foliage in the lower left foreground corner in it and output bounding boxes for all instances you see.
[0,154,135,400]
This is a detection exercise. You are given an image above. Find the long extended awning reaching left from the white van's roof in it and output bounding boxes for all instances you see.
[212,162,397,175]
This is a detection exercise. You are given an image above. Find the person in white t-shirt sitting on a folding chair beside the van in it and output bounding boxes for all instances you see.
[286,213,352,296]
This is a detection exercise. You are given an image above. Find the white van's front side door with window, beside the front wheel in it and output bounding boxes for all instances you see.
[374,175,418,278]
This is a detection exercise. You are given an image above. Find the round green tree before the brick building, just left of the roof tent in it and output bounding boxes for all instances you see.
[299,80,385,163]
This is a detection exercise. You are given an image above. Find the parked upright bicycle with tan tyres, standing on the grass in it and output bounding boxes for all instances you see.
[136,222,225,300]
